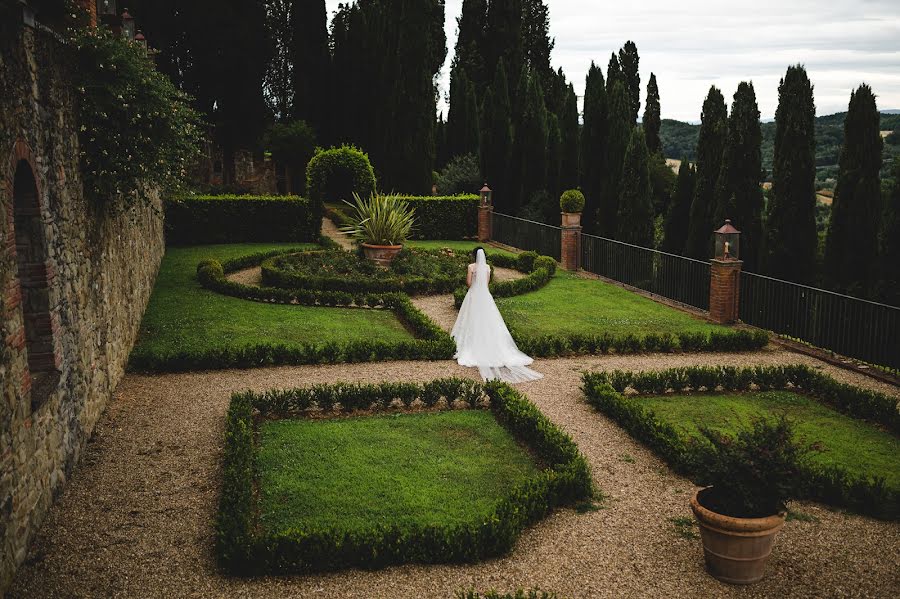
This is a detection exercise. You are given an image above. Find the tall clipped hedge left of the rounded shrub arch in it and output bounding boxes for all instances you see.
[163,195,321,245]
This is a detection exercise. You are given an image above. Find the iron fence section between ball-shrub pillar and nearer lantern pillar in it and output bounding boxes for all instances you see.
[581,234,709,310]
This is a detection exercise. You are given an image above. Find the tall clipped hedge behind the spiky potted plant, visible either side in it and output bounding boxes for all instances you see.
[325,195,481,240]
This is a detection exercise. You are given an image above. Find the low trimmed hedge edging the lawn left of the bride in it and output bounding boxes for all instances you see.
[129,249,456,372]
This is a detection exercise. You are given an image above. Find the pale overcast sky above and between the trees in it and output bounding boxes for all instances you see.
[326,0,900,121]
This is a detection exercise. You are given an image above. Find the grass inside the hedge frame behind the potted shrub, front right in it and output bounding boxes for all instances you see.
[632,391,900,489]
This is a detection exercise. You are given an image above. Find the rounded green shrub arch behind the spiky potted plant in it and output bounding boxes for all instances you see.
[306,145,376,227]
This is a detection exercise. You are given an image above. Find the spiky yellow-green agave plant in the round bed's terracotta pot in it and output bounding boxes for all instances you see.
[341,193,415,245]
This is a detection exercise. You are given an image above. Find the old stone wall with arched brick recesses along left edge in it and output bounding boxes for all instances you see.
[0,22,164,596]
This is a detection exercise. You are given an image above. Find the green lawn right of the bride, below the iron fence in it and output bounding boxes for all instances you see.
[497,270,728,337]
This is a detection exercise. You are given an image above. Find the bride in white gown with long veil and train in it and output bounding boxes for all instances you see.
[450,248,543,383]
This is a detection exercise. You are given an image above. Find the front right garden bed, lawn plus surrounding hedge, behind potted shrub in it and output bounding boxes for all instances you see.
[583,366,900,520]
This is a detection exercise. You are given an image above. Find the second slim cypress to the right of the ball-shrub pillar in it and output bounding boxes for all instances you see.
[597,81,632,237]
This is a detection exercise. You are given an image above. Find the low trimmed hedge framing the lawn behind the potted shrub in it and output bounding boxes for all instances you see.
[582,365,900,520]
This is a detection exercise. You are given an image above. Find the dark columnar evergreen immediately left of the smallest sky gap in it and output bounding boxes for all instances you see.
[290,0,331,134]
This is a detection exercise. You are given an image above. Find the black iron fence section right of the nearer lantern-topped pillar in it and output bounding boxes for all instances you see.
[740,272,900,369]
